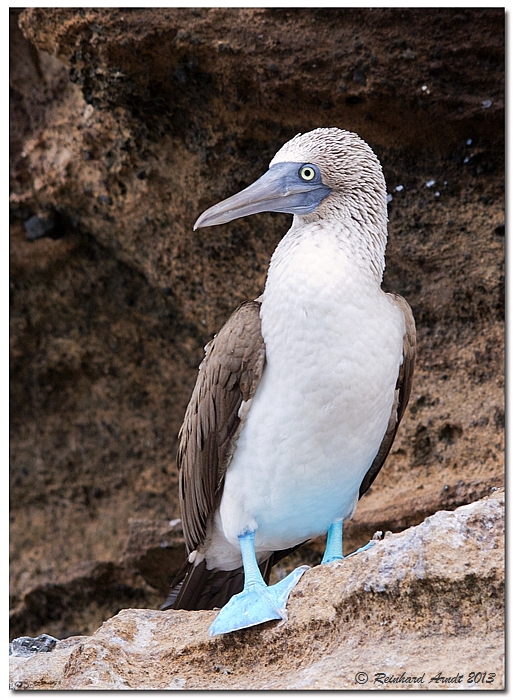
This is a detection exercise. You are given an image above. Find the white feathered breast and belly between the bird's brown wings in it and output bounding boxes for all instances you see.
[205,221,404,566]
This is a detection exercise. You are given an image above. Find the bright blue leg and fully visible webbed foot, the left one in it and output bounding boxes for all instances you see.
[209,532,309,637]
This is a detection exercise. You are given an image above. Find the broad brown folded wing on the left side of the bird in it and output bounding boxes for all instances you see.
[177,301,265,552]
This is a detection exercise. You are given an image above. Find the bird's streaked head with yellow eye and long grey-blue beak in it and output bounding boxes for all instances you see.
[193,128,386,230]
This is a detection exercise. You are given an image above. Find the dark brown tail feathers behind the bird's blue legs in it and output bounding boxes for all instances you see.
[160,543,304,610]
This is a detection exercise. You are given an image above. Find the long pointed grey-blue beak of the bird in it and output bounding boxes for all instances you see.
[193,163,331,231]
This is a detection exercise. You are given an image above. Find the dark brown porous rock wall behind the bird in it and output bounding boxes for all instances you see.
[10,8,505,637]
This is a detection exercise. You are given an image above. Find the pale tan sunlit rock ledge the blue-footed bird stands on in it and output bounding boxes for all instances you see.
[10,491,504,690]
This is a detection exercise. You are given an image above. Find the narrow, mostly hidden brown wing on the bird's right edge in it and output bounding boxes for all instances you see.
[359,294,417,498]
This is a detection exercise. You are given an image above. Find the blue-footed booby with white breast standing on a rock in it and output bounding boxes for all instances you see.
[161,127,416,636]
